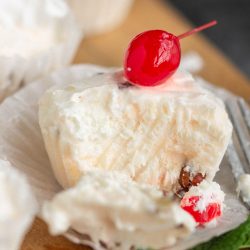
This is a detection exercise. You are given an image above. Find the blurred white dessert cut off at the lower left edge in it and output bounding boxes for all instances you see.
[0,160,37,250]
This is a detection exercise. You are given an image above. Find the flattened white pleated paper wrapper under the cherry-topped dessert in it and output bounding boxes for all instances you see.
[0,65,248,250]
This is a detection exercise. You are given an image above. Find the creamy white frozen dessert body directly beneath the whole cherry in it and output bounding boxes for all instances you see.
[39,70,232,190]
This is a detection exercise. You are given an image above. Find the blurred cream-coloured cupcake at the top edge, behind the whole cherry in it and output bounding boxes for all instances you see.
[67,0,133,35]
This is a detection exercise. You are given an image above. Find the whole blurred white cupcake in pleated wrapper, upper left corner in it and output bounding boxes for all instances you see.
[0,0,82,101]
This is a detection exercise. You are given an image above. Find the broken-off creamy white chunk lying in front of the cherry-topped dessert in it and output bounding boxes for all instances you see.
[42,170,195,249]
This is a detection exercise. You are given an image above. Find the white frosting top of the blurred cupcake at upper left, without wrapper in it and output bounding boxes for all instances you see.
[0,0,67,58]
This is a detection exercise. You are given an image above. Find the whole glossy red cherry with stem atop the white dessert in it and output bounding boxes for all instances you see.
[124,20,217,86]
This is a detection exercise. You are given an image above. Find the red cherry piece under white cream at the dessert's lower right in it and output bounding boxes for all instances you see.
[181,196,221,225]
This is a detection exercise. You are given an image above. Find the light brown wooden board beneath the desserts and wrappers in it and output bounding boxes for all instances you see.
[22,0,250,250]
